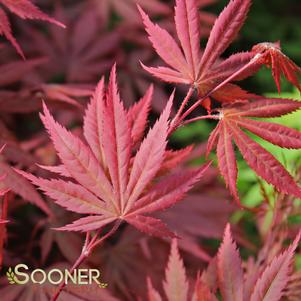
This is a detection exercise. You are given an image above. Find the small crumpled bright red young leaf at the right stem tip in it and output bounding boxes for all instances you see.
[252,42,301,93]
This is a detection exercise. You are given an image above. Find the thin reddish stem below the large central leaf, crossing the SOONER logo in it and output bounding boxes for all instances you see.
[51,220,121,301]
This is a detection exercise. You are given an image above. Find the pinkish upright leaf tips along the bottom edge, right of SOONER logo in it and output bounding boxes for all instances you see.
[147,224,300,301]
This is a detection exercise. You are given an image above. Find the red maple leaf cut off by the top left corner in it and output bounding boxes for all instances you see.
[0,0,65,58]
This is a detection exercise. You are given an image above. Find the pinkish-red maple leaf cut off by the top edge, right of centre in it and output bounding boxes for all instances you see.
[139,0,256,102]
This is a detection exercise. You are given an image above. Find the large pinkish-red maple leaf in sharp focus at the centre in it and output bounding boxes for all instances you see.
[19,67,209,236]
